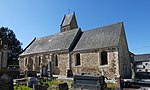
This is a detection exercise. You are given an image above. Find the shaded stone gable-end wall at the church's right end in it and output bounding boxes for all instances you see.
[118,30,131,78]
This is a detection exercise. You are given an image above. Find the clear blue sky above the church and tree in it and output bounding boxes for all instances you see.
[0,0,150,54]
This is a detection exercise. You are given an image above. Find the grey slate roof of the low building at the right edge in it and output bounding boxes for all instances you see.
[134,54,150,61]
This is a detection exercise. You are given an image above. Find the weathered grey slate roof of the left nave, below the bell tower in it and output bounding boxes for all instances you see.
[21,28,79,55]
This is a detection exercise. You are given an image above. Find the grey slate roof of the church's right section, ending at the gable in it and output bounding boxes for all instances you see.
[74,22,123,51]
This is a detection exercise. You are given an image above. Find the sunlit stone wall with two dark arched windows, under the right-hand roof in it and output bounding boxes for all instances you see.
[72,49,119,79]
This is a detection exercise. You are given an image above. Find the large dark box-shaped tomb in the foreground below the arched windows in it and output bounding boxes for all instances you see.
[74,75,106,90]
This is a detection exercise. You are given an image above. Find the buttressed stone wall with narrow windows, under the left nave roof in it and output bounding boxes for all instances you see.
[19,52,68,75]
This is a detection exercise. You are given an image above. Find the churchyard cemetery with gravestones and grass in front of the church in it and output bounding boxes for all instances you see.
[0,61,118,90]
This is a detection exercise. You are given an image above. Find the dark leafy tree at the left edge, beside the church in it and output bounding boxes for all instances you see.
[0,27,22,65]
